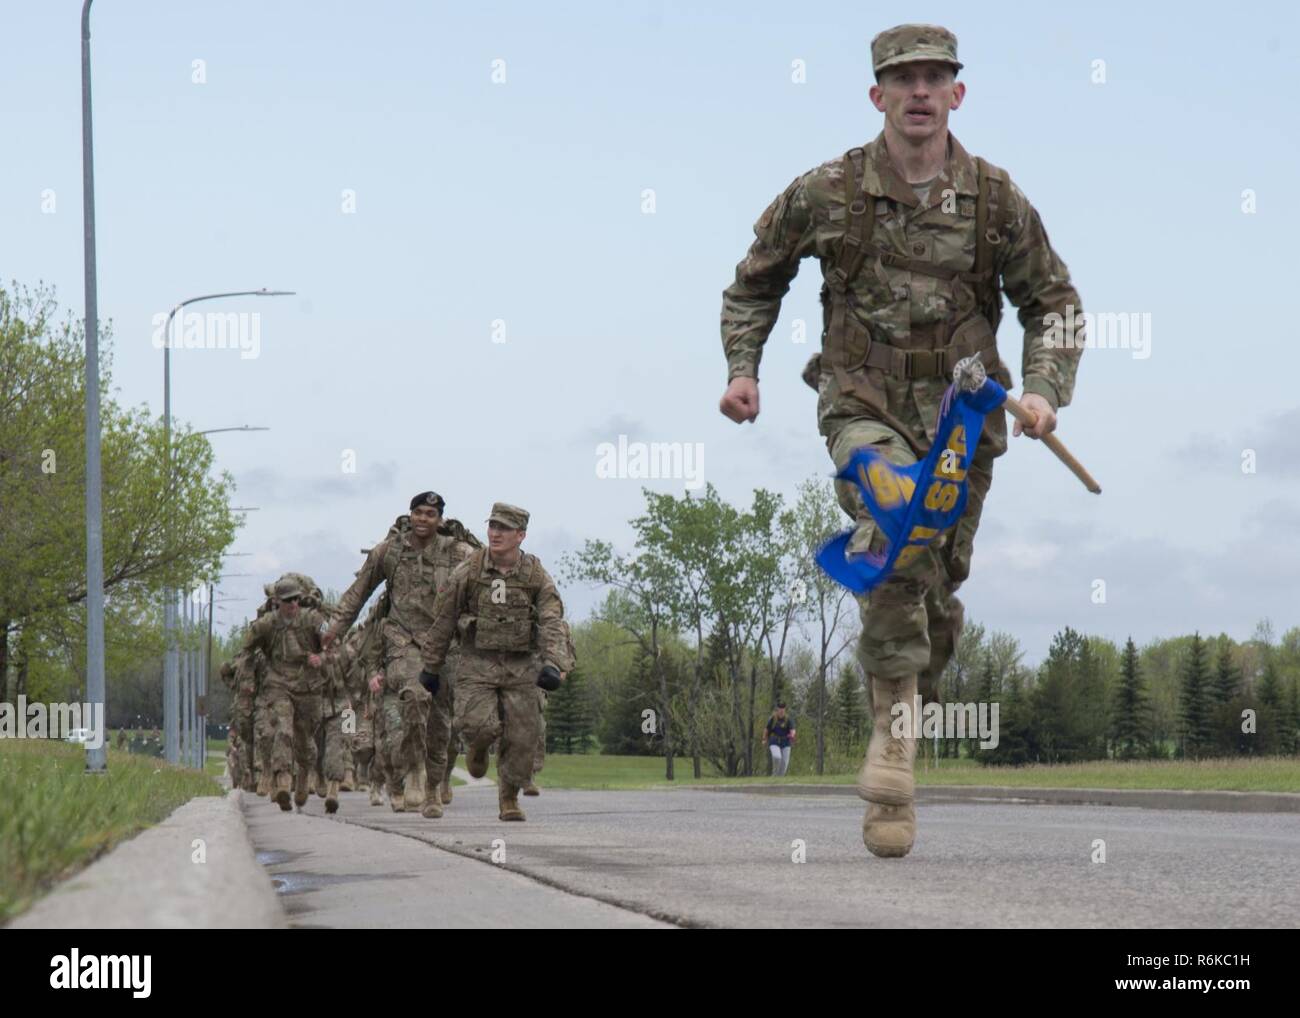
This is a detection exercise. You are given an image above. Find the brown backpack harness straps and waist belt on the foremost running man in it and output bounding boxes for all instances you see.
[821,148,1010,447]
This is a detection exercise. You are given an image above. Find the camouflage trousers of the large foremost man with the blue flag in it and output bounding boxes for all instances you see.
[818,365,1010,699]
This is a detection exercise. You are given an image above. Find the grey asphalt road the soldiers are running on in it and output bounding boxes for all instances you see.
[243,790,1300,928]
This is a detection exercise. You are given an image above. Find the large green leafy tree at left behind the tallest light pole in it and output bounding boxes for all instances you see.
[0,286,237,703]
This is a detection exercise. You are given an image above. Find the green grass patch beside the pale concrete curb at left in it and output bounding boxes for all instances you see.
[0,738,222,923]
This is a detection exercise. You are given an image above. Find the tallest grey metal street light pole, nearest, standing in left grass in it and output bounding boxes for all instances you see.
[82,0,108,774]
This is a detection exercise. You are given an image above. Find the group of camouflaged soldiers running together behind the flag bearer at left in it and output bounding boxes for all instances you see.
[221,491,573,820]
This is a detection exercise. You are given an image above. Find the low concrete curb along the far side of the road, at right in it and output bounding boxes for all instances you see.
[694,784,1300,813]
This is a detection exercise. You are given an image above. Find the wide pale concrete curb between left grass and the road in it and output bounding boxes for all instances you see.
[9,789,286,930]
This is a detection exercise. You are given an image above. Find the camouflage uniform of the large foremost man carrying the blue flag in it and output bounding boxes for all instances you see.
[722,91,1083,693]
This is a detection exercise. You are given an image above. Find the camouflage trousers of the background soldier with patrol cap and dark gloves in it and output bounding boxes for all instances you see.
[455,650,541,790]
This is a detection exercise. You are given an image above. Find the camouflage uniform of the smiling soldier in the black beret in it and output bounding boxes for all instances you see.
[334,517,473,805]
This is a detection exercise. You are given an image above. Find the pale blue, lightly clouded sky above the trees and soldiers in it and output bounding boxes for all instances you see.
[0,0,1300,660]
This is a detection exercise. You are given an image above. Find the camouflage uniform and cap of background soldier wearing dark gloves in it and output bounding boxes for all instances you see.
[424,503,572,816]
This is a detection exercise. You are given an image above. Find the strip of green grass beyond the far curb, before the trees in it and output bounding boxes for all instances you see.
[488,754,1300,792]
